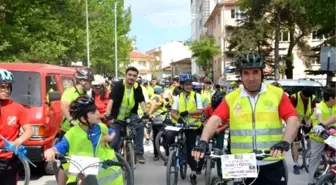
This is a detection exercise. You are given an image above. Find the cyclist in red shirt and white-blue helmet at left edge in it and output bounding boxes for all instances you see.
[0,69,33,185]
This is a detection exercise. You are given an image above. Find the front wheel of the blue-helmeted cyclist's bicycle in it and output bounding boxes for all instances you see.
[166,150,178,185]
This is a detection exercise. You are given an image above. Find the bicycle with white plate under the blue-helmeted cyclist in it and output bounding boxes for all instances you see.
[165,123,198,185]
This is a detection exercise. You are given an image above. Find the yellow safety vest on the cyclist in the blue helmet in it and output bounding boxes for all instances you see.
[172,91,202,129]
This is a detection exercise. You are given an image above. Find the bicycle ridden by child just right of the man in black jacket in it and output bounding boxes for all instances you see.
[153,111,172,162]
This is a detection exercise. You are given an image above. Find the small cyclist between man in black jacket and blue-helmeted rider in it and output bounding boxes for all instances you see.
[149,87,167,161]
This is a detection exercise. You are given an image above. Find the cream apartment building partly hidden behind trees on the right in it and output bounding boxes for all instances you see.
[204,0,323,80]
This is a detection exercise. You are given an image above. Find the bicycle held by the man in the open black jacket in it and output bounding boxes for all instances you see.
[114,118,142,169]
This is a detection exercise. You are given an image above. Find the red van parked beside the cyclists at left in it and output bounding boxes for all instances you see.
[0,63,75,174]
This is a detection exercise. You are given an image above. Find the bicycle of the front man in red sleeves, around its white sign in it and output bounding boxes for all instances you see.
[208,148,270,185]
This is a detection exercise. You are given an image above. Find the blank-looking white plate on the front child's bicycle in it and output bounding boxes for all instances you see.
[69,155,100,175]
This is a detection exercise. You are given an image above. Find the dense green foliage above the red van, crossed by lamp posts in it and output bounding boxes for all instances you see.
[0,0,132,73]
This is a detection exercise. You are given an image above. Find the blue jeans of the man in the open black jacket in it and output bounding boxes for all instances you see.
[110,114,145,155]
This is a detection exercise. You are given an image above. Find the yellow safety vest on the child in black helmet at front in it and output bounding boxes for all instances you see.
[64,123,124,185]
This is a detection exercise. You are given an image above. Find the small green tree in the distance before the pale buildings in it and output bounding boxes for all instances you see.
[186,35,220,75]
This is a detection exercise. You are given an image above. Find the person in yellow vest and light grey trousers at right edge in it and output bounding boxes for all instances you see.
[308,88,336,185]
